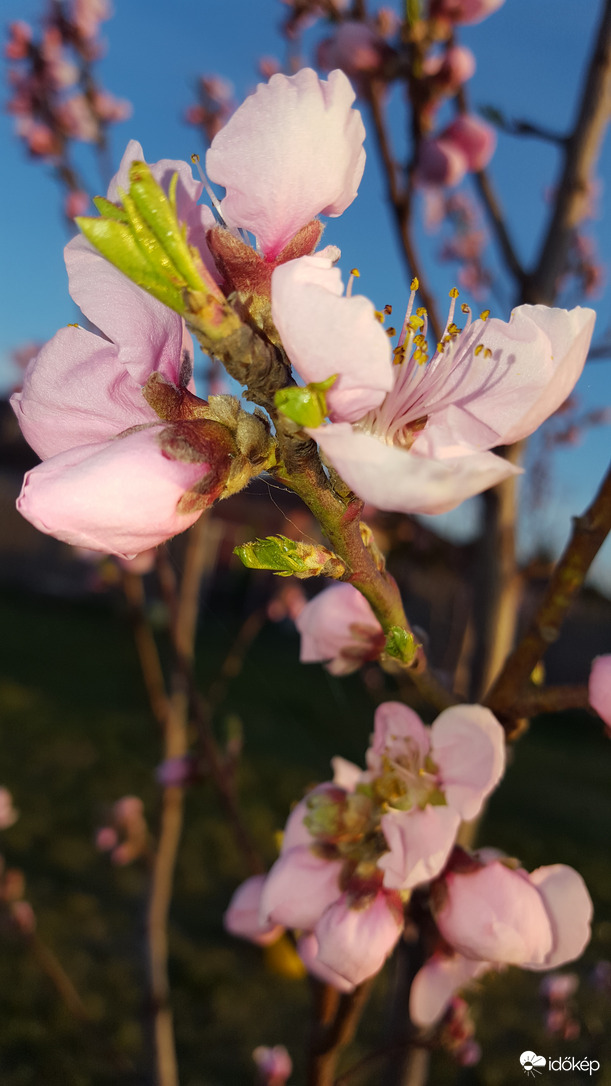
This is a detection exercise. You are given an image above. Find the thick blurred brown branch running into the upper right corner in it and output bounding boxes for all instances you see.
[523,0,611,305]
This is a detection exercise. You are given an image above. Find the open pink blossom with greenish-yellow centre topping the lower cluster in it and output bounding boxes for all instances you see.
[367,702,505,889]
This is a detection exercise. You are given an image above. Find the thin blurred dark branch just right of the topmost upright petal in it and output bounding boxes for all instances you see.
[368,80,444,341]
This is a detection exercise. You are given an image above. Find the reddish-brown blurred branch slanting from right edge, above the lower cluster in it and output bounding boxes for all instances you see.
[487,468,611,733]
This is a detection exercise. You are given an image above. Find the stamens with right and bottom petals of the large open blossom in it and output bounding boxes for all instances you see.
[307,295,595,513]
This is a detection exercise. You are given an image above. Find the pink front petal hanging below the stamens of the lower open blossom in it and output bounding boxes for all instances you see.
[378,805,460,889]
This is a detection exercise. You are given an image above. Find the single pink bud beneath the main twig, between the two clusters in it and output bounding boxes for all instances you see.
[295,583,384,674]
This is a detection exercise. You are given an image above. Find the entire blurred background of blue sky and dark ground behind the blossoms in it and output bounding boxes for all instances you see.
[0,0,611,1086]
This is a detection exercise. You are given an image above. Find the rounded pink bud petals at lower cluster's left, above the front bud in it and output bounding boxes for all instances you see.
[260,845,342,930]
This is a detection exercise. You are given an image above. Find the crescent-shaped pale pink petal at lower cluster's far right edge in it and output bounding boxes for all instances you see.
[525,863,593,970]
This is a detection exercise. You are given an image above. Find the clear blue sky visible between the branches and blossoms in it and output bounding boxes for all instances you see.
[0,0,611,589]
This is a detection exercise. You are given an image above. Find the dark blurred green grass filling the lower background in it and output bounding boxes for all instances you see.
[0,594,611,1086]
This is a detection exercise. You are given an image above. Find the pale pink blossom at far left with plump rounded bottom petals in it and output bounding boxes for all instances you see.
[11,239,230,557]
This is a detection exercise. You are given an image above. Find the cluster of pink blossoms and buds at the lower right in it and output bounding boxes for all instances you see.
[226,702,591,1039]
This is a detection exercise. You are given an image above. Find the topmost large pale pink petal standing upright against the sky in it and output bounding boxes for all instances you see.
[206,68,365,260]
